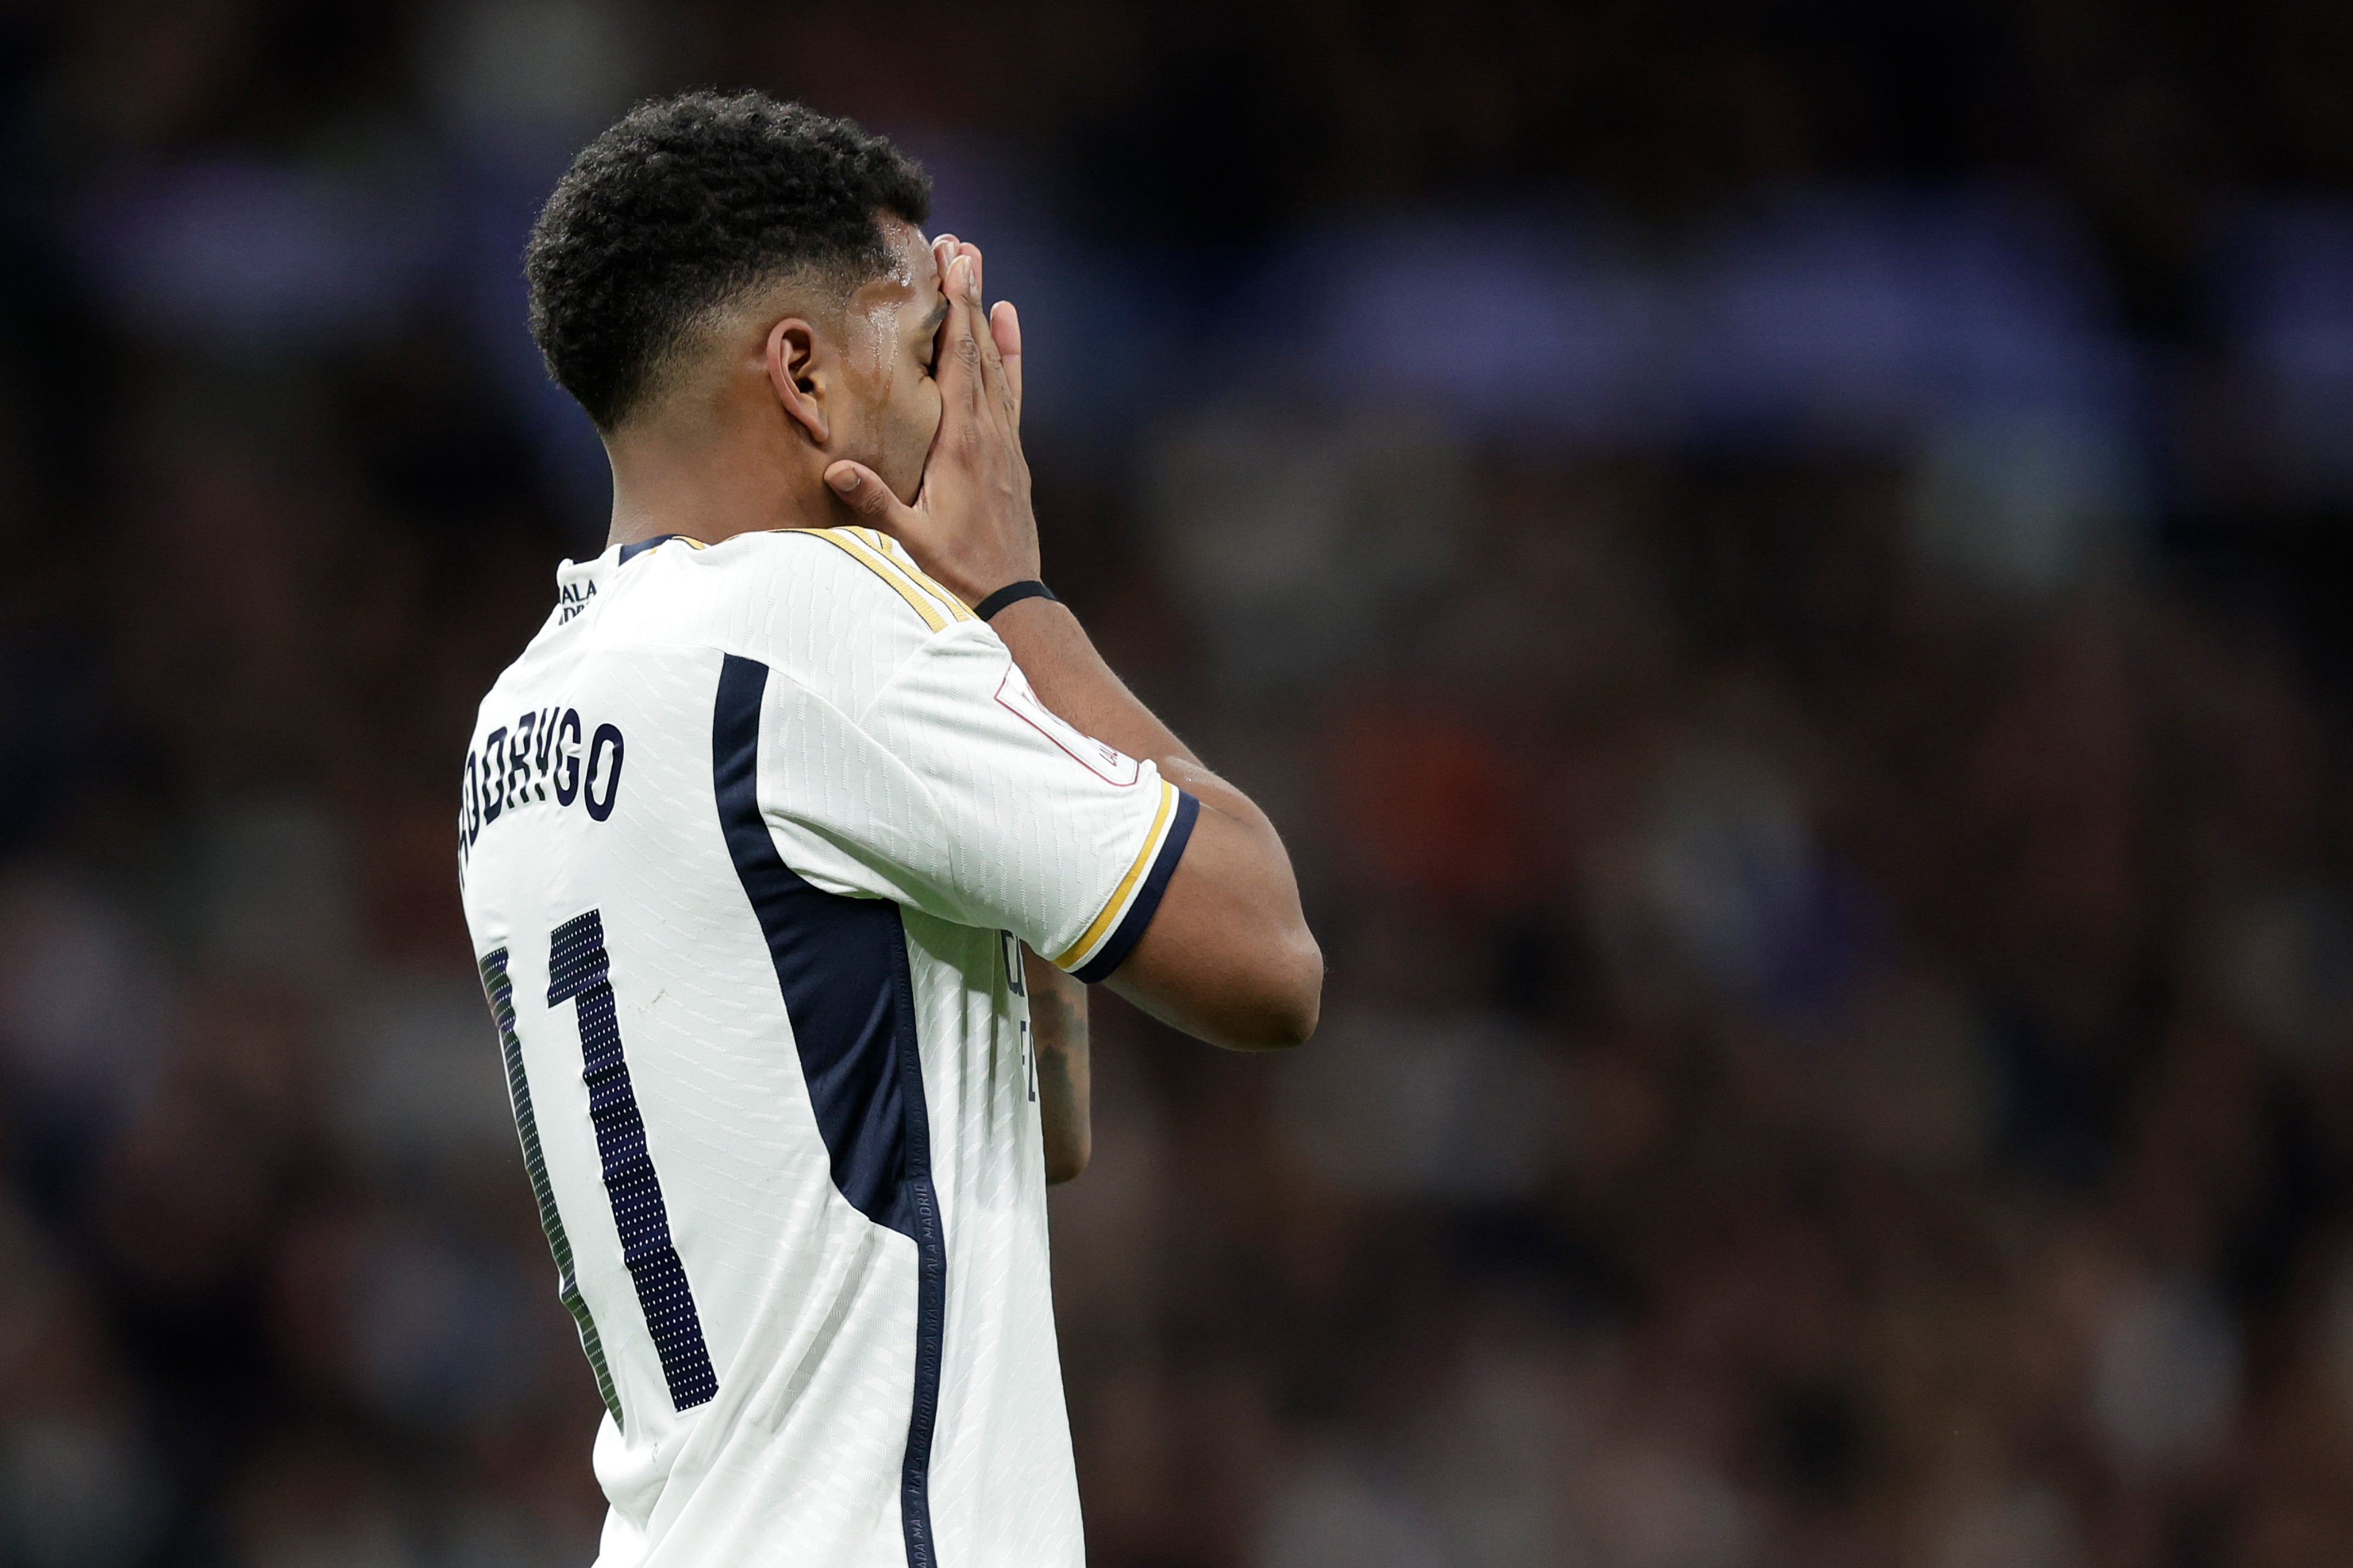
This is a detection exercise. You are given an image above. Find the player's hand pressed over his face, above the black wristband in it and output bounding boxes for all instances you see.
[826,240,1037,604]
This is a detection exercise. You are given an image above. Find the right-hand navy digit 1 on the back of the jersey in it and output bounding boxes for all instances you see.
[548,910,720,1410]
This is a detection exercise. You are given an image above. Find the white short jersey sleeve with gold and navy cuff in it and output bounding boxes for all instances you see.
[758,621,1198,980]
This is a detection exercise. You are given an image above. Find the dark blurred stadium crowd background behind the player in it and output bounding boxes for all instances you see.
[0,0,2353,1568]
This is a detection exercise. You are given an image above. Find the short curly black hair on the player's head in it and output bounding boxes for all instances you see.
[523,90,932,430]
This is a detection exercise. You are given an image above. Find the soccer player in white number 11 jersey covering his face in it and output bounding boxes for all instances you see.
[461,92,1322,1568]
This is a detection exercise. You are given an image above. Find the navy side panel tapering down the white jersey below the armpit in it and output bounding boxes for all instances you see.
[711,654,948,1568]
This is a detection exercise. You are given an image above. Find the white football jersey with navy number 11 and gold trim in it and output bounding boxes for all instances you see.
[459,529,1195,1568]
